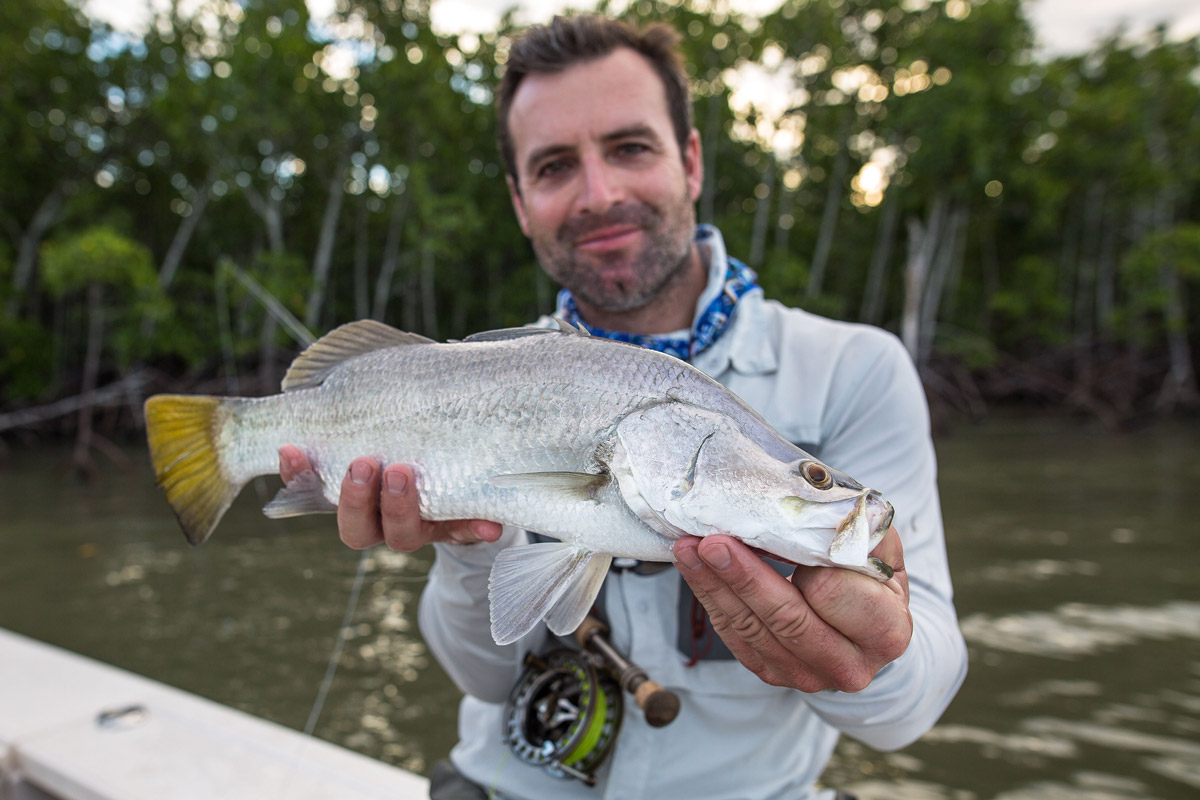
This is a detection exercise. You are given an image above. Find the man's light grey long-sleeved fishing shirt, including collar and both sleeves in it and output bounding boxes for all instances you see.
[420,229,966,800]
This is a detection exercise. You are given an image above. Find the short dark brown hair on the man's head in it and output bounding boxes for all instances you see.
[496,14,691,187]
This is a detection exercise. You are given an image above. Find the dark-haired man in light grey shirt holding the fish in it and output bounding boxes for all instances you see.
[281,17,966,800]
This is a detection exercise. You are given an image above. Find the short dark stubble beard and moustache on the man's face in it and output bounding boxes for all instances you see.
[533,198,696,313]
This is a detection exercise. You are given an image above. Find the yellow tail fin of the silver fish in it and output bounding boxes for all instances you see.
[145,395,241,545]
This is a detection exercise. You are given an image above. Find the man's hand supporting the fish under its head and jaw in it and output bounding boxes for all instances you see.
[674,528,912,692]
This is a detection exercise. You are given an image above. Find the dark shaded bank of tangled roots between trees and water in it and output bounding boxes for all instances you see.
[0,345,1200,476]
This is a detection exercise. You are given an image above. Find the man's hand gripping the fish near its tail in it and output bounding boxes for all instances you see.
[280,445,500,553]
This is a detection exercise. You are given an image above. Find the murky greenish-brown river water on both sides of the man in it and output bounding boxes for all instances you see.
[0,420,1200,800]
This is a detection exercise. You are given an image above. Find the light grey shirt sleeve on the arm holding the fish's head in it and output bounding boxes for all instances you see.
[777,314,967,750]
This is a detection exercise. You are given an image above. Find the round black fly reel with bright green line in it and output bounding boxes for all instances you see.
[504,648,624,786]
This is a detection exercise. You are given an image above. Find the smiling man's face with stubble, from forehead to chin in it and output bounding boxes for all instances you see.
[509,48,702,312]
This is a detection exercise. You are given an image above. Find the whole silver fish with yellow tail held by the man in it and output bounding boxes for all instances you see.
[144,320,893,644]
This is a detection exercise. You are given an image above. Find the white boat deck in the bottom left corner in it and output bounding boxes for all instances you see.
[0,628,428,800]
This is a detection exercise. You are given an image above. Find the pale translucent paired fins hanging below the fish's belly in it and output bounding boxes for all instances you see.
[487,542,612,644]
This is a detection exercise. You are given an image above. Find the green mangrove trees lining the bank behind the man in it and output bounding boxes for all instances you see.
[0,0,1200,412]
